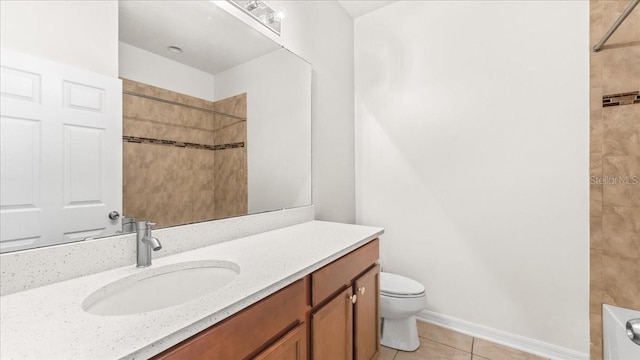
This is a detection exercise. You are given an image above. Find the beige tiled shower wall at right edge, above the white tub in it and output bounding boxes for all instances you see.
[590,0,640,360]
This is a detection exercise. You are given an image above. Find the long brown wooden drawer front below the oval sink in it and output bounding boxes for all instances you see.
[154,280,307,360]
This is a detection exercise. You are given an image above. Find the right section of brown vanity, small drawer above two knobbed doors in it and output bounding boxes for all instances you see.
[310,239,380,360]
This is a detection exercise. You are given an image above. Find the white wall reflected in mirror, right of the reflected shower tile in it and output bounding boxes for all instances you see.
[215,49,311,214]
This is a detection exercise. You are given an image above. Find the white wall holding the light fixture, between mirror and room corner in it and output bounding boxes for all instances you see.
[216,0,355,223]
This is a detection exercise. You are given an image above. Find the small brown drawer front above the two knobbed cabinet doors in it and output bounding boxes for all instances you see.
[311,239,379,307]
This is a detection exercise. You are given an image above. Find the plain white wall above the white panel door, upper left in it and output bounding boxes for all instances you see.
[0,1,118,77]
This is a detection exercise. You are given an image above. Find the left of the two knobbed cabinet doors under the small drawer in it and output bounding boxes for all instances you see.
[311,287,353,360]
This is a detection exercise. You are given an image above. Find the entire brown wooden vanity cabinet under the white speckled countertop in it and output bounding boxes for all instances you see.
[153,239,380,360]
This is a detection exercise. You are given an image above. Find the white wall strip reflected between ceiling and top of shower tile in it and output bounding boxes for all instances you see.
[118,42,214,101]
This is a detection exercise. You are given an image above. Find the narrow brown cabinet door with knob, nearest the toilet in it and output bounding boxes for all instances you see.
[354,265,380,360]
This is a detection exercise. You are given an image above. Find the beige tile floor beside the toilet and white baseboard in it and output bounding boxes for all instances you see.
[378,321,545,360]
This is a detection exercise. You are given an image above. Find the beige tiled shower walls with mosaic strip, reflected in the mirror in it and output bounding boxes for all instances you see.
[123,79,247,227]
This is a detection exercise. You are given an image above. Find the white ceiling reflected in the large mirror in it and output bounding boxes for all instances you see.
[119,1,280,74]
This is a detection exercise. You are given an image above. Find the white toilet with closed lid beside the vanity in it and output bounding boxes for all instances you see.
[380,272,427,351]
